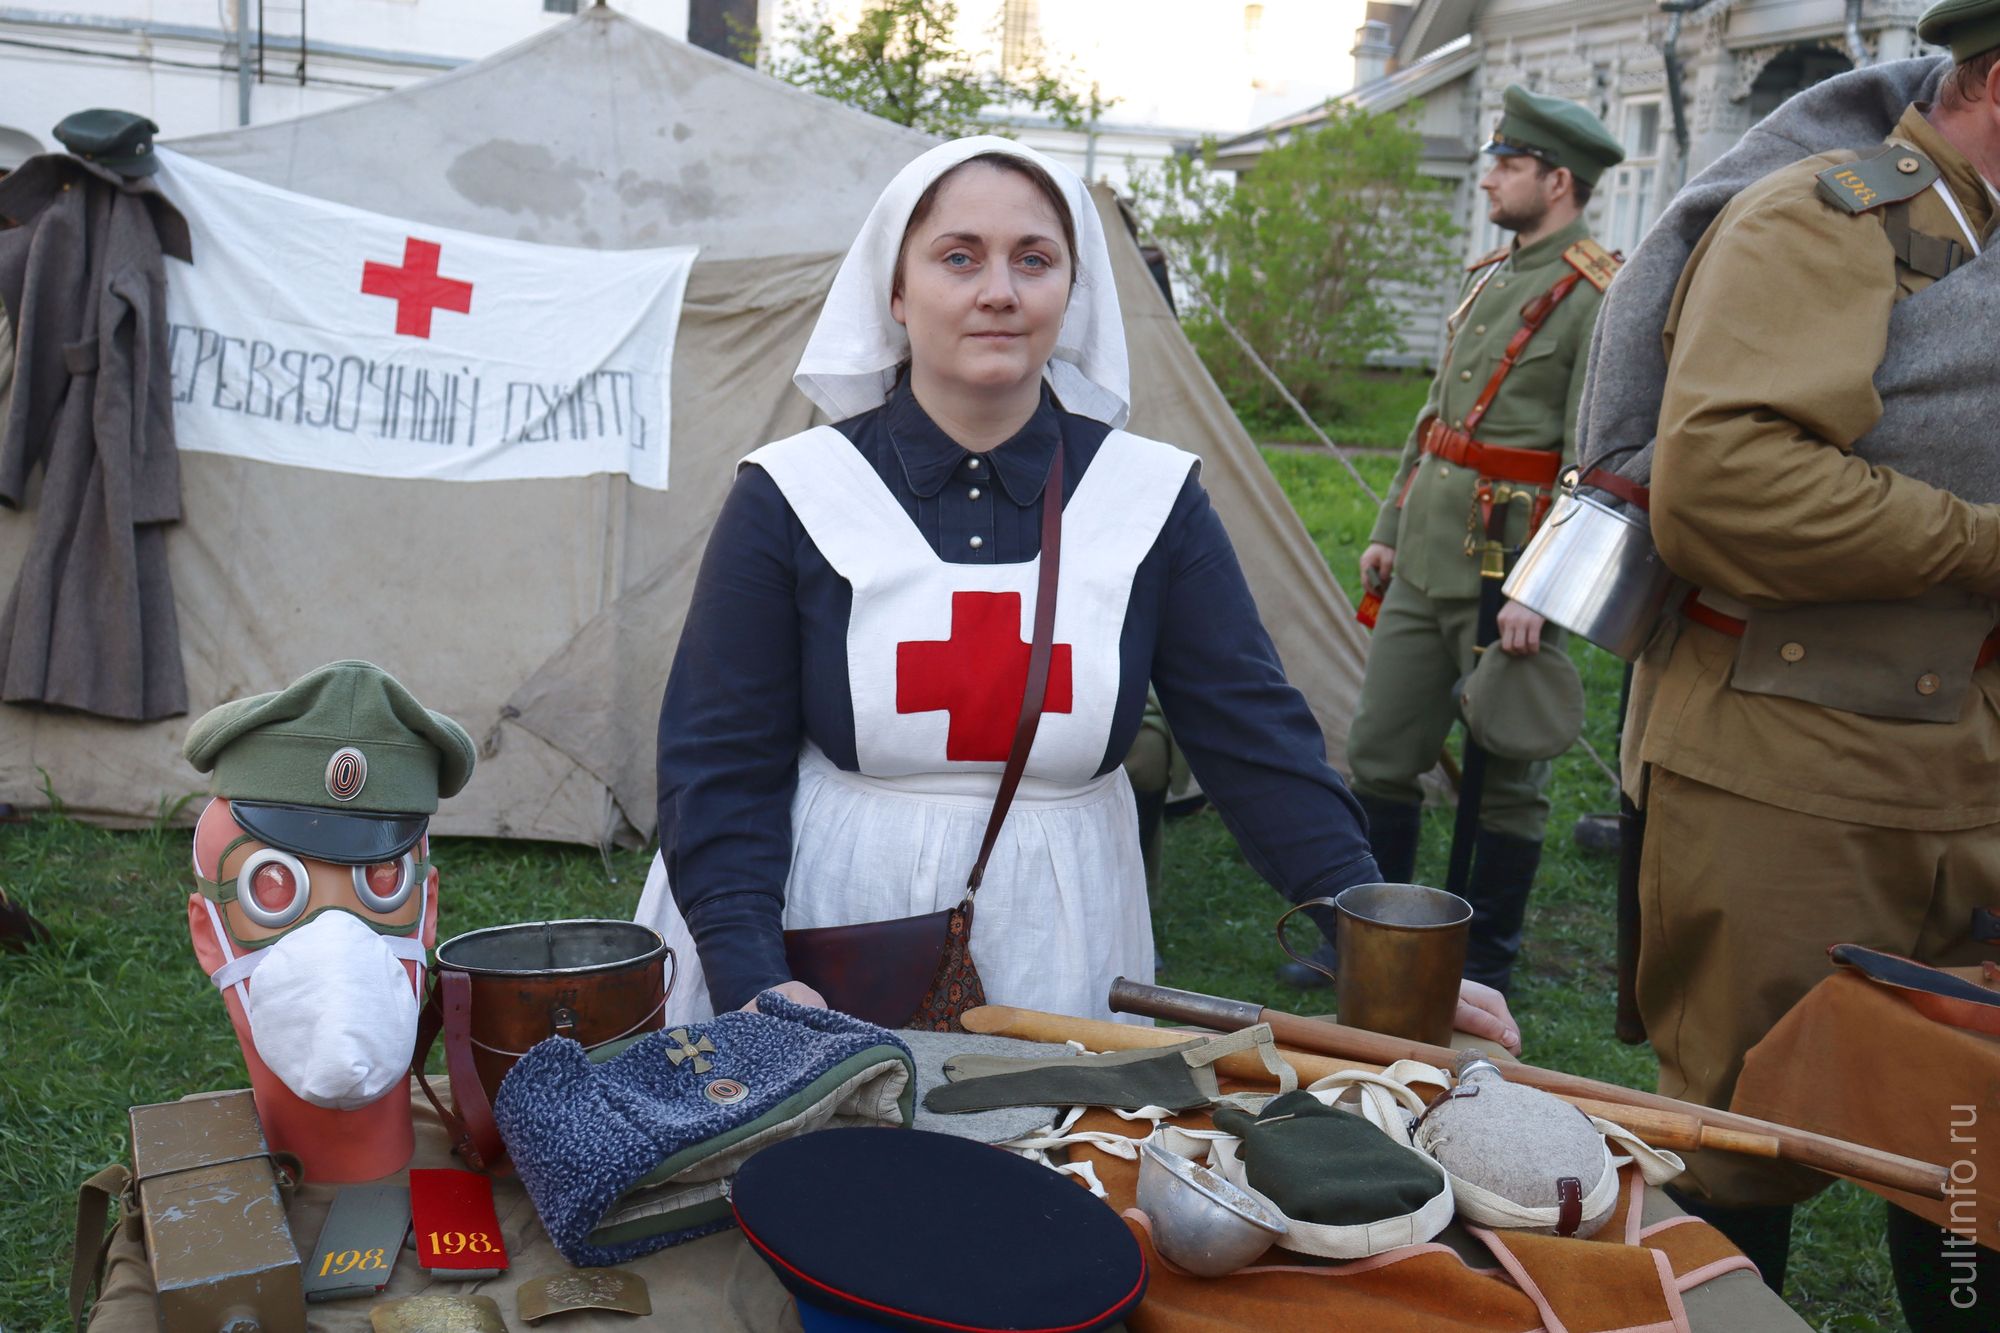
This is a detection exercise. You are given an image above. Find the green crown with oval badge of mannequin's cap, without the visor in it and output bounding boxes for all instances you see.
[182,662,476,815]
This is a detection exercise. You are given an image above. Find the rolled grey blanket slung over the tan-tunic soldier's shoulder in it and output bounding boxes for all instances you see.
[1578,56,2000,502]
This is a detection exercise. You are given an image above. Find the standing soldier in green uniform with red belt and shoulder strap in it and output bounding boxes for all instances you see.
[1284,84,1624,991]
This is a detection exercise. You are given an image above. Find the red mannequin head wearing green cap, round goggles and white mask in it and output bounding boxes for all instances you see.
[184,662,474,1136]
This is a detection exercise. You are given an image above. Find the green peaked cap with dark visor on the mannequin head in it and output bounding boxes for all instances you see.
[182,662,476,865]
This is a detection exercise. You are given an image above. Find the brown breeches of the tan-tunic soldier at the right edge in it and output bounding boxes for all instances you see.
[1638,767,2000,1207]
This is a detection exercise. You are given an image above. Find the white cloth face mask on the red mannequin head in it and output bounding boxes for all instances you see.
[210,896,424,1111]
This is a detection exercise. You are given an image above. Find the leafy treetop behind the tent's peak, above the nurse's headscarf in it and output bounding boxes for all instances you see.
[752,0,1092,136]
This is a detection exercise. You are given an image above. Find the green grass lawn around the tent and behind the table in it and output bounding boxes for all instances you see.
[0,452,1904,1331]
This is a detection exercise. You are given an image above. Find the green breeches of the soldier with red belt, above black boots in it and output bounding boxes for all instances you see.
[1348,578,1564,843]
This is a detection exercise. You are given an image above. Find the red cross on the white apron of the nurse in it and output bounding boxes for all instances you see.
[896,592,1072,763]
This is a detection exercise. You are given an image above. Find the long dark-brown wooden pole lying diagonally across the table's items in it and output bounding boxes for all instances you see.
[1110,977,1946,1199]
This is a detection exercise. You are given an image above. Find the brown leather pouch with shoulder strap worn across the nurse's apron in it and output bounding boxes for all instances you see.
[784,448,1062,1033]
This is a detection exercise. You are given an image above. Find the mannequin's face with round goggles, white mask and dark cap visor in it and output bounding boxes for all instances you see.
[194,799,436,1109]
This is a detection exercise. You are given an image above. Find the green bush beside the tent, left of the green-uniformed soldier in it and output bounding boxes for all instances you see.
[1134,102,1458,422]
